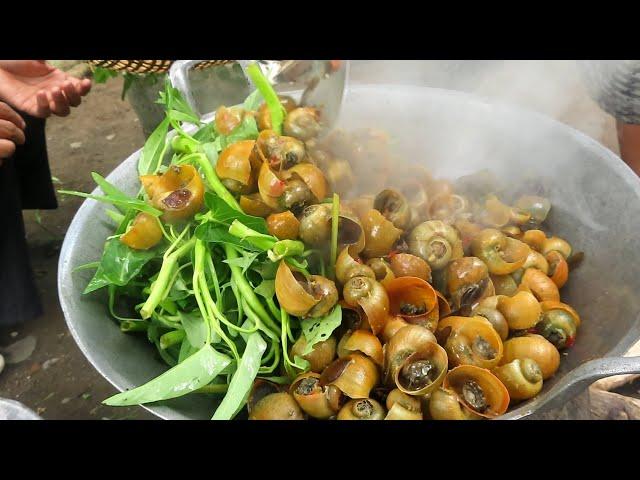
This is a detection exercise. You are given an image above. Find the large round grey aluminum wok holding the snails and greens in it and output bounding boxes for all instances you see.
[58,85,640,419]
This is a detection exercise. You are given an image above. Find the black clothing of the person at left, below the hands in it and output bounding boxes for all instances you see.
[0,112,58,327]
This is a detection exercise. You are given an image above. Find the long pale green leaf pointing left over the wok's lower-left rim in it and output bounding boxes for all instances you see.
[102,345,234,407]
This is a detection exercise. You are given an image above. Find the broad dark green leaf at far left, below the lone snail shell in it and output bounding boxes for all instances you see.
[101,237,158,287]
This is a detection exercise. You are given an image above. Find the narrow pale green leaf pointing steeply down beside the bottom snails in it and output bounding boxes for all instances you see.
[211,332,267,420]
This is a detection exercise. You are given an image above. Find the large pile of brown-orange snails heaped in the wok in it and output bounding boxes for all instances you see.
[216,95,581,420]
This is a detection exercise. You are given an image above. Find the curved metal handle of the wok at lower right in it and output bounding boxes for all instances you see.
[520,357,640,413]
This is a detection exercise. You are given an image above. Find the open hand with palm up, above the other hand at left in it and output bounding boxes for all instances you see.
[0,60,91,118]
